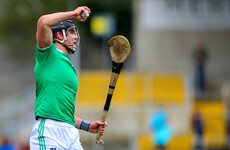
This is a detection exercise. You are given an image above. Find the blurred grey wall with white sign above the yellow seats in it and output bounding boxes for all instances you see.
[133,0,230,99]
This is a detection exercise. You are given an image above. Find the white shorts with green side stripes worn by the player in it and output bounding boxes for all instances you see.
[30,119,83,150]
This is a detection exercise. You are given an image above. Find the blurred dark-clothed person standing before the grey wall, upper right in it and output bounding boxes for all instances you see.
[194,40,207,97]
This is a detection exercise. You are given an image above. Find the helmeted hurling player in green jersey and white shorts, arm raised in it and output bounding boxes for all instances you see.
[30,6,107,150]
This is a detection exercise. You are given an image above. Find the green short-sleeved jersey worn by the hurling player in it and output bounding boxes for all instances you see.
[34,43,79,126]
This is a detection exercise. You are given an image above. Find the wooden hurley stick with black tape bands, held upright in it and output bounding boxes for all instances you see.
[96,35,131,145]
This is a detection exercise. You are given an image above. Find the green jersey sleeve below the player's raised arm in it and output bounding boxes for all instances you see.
[36,42,55,62]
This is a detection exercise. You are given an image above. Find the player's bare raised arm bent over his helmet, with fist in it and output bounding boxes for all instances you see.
[36,6,91,48]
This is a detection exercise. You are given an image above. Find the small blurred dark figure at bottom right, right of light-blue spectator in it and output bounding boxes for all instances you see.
[192,112,204,150]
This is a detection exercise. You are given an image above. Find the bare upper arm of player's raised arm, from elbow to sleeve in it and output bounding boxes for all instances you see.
[36,16,53,48]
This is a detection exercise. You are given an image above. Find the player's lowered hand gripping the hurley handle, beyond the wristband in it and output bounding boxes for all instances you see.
[88,121,107,135]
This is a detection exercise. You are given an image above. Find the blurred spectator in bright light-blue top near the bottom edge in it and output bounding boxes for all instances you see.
[150,110,172,150]
